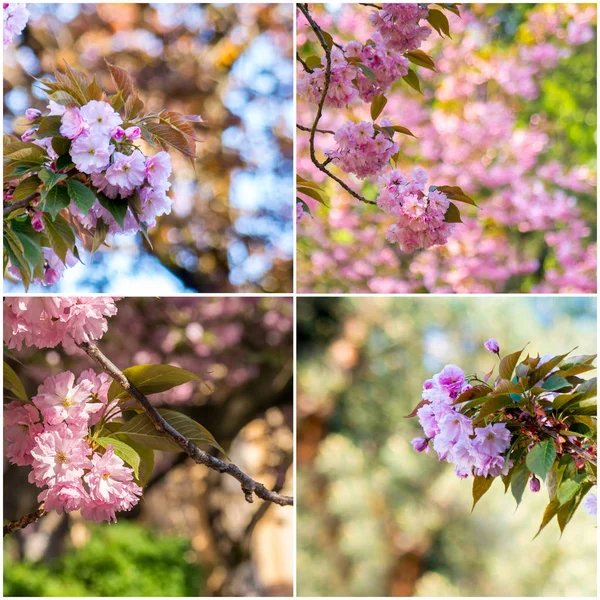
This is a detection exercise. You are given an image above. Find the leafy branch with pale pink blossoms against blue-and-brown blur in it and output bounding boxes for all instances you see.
[3,57,201,289]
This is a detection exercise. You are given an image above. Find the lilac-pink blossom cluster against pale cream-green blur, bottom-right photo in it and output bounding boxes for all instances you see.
[412,365,511,479]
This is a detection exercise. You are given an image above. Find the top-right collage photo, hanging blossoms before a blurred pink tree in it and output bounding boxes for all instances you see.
[296,3,597,294]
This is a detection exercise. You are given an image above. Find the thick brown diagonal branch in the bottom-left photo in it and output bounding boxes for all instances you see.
[77,342,294,506]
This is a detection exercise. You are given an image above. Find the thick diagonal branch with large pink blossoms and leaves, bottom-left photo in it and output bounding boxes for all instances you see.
[3,297,293,535]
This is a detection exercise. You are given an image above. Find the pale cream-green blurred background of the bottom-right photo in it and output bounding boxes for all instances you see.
[297,297,597,596]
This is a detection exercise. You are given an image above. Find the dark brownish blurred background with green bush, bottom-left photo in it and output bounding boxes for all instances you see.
[4,297,294,597]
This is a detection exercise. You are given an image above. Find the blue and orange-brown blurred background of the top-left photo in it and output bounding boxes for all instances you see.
[4,3,293,294]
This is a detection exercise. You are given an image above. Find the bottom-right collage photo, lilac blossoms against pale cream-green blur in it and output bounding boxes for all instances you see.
[296,296,597,597]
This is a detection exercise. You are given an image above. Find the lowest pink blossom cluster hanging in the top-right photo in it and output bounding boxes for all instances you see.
[377,169,456,252]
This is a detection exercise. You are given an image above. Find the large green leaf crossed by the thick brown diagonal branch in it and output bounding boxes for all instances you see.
[120,408,227,456]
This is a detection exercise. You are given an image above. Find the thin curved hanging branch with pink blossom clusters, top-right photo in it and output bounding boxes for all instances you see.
[296,4,475,252]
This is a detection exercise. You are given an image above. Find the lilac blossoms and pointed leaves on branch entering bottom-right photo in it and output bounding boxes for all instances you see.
[407,339,598,534]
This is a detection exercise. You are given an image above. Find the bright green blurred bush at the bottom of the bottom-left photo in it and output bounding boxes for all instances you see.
[4,522,204,597]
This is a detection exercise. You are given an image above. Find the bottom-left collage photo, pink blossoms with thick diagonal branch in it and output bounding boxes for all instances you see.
[3,296,295,597]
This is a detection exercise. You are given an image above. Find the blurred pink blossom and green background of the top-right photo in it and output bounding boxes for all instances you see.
[297,3,597,294]
